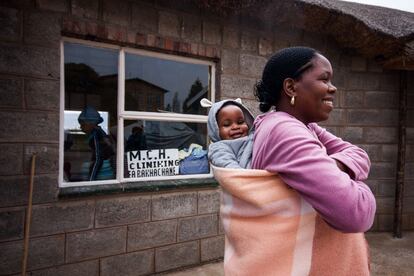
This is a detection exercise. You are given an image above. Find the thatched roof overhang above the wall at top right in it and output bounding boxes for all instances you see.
[157,0,414,70]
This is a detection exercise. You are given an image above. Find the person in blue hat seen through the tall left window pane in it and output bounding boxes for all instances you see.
[78,106,115,181]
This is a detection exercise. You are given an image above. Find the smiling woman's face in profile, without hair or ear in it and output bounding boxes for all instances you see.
[294,54,336,124]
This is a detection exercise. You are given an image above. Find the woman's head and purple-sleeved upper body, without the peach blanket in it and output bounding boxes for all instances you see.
[252,47,375,232]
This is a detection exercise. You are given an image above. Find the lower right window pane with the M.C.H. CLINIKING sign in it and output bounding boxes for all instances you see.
[124,120,209,178]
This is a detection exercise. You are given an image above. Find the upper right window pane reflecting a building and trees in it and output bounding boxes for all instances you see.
[125,53,210,115]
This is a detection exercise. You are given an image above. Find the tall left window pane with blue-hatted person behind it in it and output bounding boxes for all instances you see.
[64,43,118,181]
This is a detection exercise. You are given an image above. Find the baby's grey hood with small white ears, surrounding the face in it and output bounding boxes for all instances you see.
[207,99,254,143]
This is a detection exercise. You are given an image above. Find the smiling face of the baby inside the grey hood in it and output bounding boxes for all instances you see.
[217,105,249,140]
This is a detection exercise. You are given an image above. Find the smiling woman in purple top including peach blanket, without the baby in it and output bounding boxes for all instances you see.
[213,47,376,276]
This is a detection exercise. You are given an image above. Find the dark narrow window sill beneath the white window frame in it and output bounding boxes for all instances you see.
[59,178,218,198]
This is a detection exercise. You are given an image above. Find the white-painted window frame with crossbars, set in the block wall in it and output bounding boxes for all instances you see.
[59,37,216,188]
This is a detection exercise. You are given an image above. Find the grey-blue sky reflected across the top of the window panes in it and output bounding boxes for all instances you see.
[65,42,209,113]
